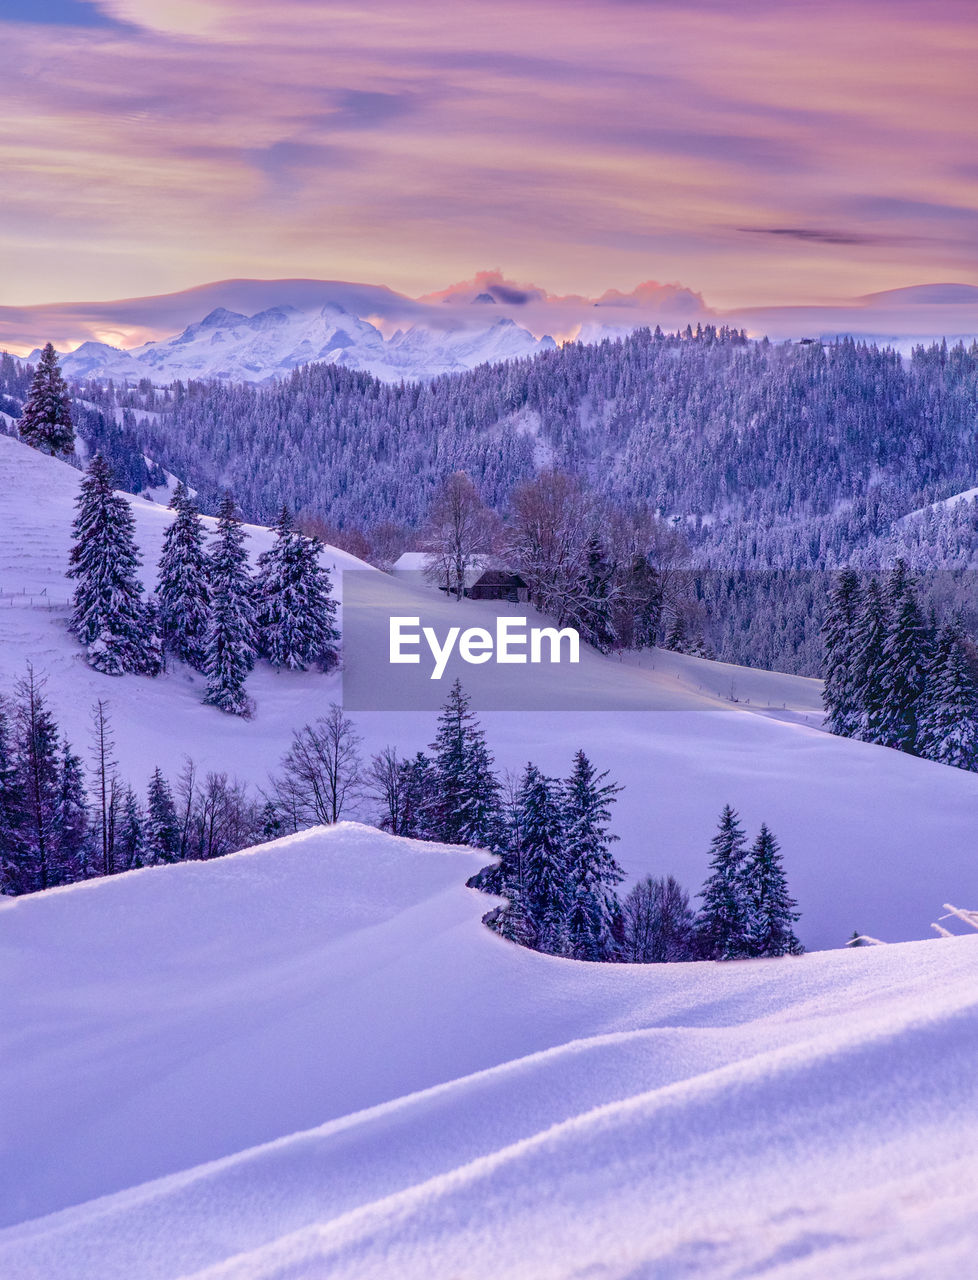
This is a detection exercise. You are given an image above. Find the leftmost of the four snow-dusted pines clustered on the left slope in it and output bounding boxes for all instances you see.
[68,454,156,676]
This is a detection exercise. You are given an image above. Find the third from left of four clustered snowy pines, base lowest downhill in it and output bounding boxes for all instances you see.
[204,494,255,716]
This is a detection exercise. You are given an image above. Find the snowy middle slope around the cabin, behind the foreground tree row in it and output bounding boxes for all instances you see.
[0,436,978,947]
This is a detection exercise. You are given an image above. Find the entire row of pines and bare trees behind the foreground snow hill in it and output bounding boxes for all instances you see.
[0,668,800,963]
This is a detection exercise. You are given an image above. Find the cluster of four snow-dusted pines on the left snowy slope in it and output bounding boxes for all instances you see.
[68,454,339,716]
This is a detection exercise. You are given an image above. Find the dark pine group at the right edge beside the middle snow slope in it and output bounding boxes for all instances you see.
[823,559,978,769]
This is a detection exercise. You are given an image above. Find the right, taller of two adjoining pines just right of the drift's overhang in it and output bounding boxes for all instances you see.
[562,751,625,960]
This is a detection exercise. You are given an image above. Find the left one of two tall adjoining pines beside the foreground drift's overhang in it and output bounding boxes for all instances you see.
[512,764,572,955]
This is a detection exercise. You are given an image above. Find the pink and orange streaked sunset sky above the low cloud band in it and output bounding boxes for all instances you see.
[0,0,978,307]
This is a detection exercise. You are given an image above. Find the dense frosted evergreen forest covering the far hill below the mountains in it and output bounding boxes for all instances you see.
[0,326,978,673]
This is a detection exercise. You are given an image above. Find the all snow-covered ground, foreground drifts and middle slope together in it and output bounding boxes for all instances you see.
[0,436,978,1280]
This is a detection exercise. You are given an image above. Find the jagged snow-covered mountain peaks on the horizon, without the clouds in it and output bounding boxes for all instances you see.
[28,303,556,385]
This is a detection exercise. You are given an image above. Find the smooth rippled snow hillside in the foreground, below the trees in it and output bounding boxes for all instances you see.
[0,819,978,1280]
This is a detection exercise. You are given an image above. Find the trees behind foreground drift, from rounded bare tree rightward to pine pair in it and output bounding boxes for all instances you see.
[284,681,801,963]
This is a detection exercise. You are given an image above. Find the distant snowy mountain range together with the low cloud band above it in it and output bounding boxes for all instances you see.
[0,271,978,383]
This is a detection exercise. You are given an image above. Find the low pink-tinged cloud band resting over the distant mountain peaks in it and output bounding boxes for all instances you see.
[7,270,978,376]
